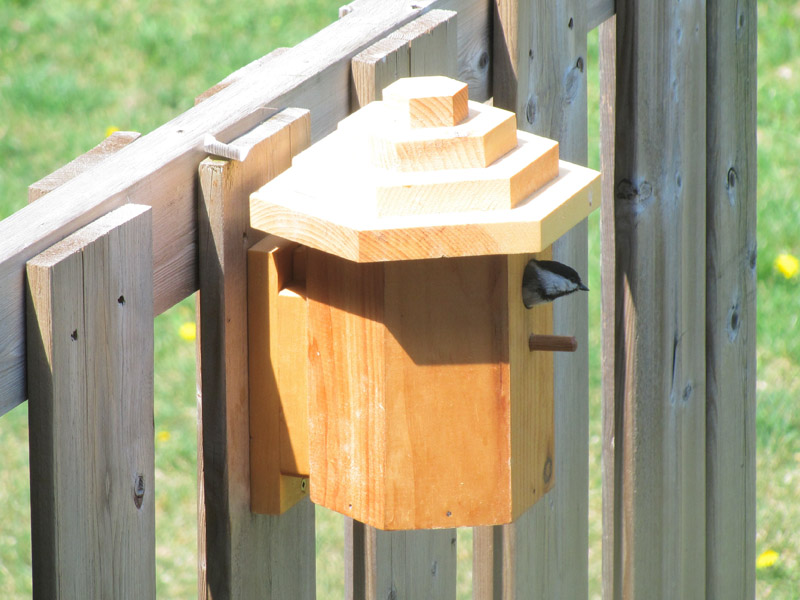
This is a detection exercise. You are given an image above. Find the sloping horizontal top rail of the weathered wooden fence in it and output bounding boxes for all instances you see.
[0,0,490,414]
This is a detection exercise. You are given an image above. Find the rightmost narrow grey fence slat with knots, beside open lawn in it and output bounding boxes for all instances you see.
[706,0,757,599]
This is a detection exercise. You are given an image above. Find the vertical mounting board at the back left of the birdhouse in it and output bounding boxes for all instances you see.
[247,236,309,515]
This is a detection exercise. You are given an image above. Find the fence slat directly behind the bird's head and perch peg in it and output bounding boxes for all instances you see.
[475,0,589,598]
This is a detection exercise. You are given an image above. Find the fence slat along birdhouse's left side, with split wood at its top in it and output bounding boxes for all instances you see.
[198,109,315,599]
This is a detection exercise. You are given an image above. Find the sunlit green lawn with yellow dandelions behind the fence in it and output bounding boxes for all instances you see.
[0,0,800,599]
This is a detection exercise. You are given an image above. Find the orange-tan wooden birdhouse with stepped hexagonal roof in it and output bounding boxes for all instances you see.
[248,77,600,530]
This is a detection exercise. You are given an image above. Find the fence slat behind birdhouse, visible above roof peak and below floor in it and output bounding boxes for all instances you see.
[345,10,457,599]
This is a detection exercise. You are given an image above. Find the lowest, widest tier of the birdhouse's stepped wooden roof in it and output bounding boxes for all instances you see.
[250,161,600,262]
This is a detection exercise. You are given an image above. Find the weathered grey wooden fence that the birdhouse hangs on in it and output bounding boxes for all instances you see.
[0,0,756,599]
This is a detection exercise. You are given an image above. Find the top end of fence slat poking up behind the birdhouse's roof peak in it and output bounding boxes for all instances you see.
[352,10,458,111]
